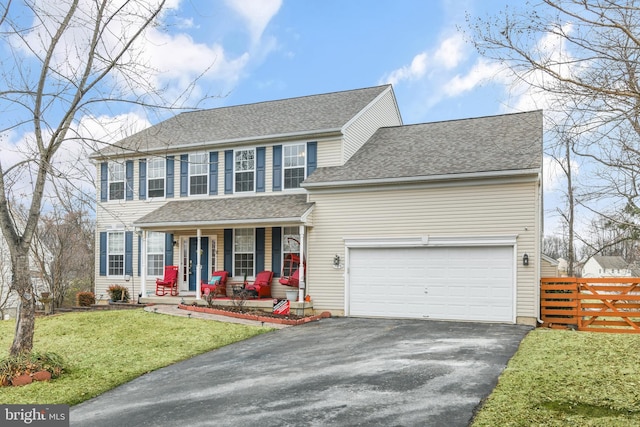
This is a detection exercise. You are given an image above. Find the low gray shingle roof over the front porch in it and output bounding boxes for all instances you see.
[134,194,314,227]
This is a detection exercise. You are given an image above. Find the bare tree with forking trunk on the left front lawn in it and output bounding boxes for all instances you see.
[0,0,209,355]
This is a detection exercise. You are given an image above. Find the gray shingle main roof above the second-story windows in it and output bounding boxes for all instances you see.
[95,85,390,157]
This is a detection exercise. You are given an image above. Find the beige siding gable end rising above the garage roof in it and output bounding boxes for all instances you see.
[342,90,402,163]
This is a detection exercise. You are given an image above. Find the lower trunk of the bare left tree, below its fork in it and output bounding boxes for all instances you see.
[9,252,36,356]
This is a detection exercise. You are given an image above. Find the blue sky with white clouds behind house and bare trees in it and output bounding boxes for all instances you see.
[0,0,559,231]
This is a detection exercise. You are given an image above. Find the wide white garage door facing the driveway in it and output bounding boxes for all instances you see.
[348,246,514,322]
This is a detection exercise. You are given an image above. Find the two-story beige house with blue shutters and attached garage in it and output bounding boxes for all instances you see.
[92,85,542,324]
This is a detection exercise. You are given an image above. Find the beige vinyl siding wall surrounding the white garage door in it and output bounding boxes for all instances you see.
[307,178,539,324]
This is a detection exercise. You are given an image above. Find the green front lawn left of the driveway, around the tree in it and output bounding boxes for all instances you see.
[0,309,272,405]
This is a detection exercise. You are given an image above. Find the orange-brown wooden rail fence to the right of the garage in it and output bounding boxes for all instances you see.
[540,277,640,333]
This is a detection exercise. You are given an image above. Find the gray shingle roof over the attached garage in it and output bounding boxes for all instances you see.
[303,111,542,187]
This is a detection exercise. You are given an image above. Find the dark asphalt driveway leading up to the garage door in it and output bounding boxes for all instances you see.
[70,318,531,427]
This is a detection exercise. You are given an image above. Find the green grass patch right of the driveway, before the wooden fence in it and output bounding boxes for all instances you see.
[473,329,640,427]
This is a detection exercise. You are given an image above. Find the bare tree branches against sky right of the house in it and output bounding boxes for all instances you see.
[468,0,640,260]
